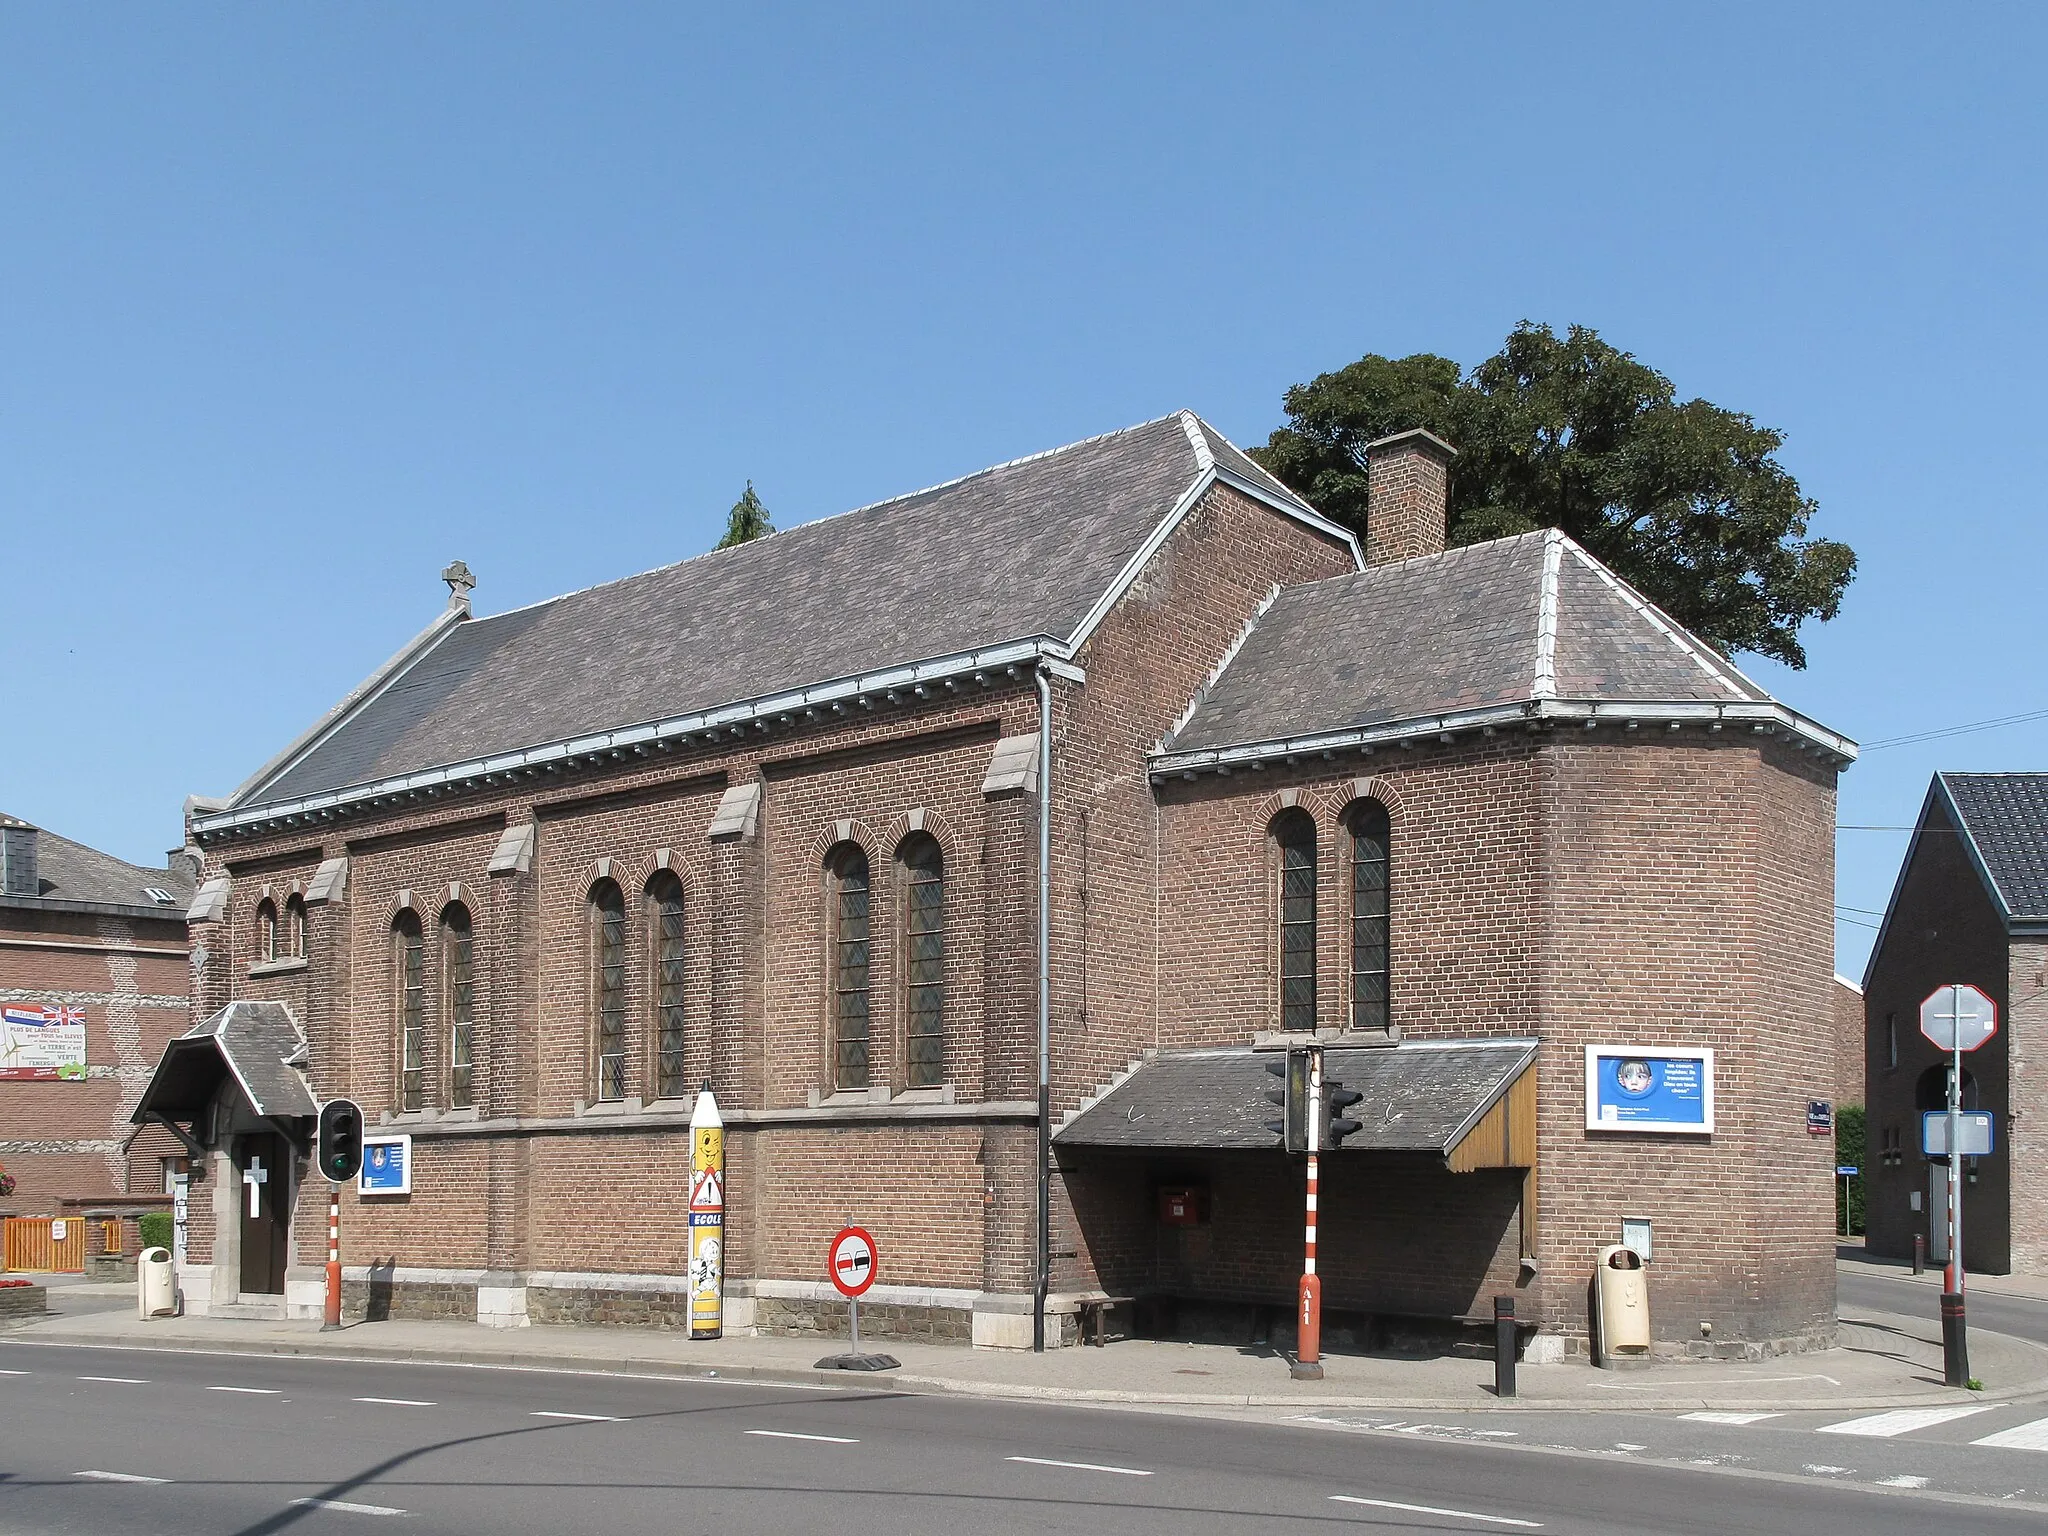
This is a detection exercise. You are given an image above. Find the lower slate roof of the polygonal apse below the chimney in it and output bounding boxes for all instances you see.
[1161,530,1769,754]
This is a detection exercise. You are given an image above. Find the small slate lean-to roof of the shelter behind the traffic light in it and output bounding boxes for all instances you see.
[1053,1040,1536,1153]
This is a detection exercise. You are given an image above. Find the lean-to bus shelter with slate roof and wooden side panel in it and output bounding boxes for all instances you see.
[1053,1038,1536,1343]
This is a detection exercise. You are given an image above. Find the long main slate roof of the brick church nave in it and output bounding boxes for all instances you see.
[216,412,1356,827]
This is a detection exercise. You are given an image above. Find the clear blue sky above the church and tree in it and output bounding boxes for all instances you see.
[0,4,2048,975]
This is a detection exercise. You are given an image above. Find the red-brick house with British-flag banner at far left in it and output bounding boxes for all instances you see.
[0,815,197,1268]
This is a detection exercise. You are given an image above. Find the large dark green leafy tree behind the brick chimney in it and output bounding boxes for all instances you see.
[1253,322,1855,668]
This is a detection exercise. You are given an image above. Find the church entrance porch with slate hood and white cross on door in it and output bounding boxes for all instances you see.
[133,1001,319,1315]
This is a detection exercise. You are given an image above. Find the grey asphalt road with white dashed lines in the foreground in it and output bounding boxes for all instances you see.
[0,1339,2048,1536]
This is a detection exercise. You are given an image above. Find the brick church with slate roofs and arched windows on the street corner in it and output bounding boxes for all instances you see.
[128,414,1853,1350]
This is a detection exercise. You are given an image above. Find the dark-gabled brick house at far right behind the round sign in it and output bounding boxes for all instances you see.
[1864,774,2048,1274]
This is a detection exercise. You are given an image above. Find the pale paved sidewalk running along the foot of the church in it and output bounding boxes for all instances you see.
[0,1286,2048,1413]
